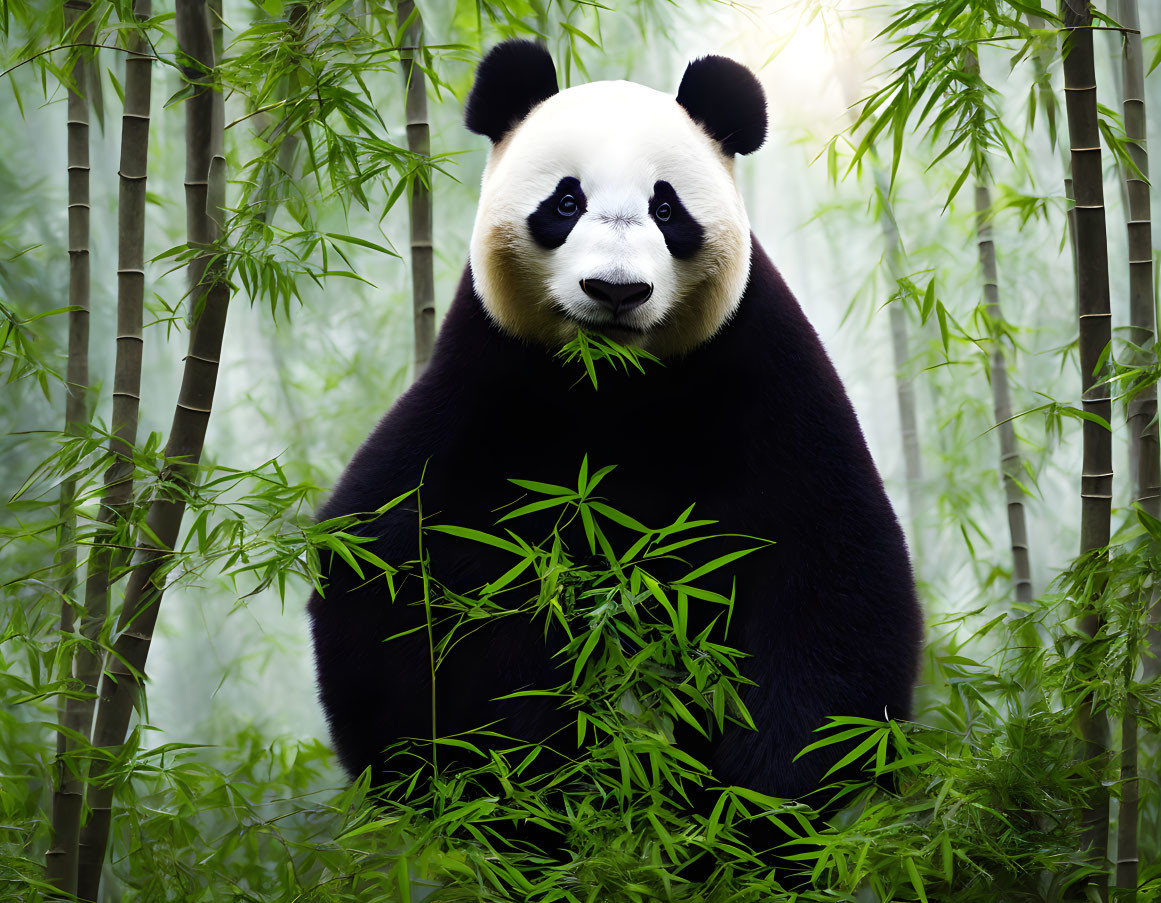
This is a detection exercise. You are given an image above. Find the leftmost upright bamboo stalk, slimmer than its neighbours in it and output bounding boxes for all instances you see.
[44,0,93,894]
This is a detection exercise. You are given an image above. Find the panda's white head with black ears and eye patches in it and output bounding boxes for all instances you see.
[464,41,766,356]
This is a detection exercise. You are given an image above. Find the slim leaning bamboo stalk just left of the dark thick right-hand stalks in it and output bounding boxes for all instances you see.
[975,180,1033,605]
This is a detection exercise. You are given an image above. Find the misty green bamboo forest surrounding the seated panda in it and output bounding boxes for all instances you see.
[0,0,1161,901]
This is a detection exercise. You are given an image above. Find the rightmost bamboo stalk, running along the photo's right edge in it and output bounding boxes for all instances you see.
[1116,0,1147,902]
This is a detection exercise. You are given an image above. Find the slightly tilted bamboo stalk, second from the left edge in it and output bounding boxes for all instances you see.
[66,0,152,900]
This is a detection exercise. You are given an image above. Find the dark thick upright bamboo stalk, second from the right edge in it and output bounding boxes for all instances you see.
[1061,0,1112,900]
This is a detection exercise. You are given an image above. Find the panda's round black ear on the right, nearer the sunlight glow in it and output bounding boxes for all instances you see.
[677,57,766,154]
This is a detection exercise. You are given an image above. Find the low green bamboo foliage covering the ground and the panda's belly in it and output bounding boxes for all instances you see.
[11,462,1161,902]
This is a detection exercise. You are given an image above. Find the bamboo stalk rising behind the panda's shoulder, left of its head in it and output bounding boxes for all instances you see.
[395,0,435,380]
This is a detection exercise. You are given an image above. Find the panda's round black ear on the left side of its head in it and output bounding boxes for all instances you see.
[463,41,557,144]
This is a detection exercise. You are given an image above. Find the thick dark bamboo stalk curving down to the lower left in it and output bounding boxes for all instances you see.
[74,0,230,898]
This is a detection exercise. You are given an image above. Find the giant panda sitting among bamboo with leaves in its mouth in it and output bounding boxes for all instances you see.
[309,42,922,849]
